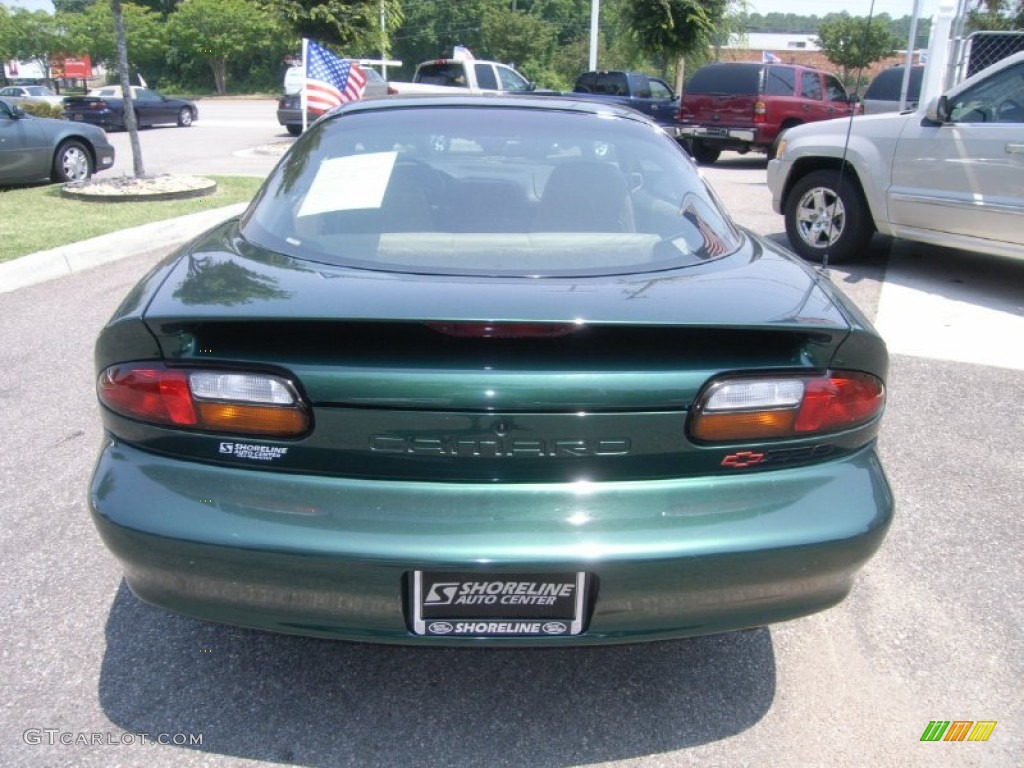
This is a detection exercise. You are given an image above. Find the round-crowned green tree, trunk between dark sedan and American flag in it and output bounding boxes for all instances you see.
[167,0,281,93]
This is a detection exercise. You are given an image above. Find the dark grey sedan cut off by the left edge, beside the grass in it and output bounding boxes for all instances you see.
[0,98,114,184]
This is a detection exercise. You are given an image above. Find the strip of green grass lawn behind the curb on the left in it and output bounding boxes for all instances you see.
[0,176,263,261]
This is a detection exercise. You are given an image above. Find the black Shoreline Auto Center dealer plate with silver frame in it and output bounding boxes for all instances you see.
[413,570,587,637]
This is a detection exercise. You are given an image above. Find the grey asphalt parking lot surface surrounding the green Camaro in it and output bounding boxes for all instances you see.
[0,102,1024,768]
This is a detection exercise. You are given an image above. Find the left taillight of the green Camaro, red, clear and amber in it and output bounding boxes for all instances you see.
[97,364,309,437]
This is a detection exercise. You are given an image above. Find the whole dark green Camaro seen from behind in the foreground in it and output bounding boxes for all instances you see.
[90,96,893,646]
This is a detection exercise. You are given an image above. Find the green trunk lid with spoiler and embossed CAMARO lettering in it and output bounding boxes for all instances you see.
[132,225,850,481]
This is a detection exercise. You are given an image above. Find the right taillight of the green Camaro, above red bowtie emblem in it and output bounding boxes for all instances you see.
[689,372,885,442]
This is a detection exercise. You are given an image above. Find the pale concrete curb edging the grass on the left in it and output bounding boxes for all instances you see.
[0,203,248,293]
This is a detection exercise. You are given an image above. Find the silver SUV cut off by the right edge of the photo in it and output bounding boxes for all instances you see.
[768,53,1024,262]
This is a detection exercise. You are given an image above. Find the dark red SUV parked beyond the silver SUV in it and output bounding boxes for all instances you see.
[678,61,857,164]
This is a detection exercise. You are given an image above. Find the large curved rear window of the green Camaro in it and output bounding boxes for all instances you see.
[242,105,741,276]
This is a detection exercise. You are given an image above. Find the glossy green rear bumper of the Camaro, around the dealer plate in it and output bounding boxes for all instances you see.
[89,441,893,645]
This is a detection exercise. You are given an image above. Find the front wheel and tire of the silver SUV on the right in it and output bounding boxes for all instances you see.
[784,170,874,263]
